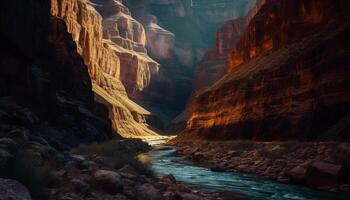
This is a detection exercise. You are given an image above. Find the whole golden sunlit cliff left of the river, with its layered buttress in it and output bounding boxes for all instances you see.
[51,0,161,137]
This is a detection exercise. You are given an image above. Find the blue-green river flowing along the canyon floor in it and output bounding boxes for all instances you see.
[141,145,350,200]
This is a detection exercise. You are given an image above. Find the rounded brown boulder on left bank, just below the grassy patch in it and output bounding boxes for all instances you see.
[92,170,123,194]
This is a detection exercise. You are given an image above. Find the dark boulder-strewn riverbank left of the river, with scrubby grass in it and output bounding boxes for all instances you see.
[0,139,224,200]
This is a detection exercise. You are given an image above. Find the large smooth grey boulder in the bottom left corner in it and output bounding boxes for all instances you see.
[0,178,32,200]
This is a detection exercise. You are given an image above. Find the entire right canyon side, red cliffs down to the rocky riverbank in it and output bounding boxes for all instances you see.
[168,0,350,193]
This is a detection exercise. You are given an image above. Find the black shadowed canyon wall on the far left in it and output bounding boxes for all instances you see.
[0,0,117,149]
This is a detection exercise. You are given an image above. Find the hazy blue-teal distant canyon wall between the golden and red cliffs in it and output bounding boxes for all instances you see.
[125,0,253,125]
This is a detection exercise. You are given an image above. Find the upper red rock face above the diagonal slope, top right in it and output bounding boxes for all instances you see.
[229,0,347,71]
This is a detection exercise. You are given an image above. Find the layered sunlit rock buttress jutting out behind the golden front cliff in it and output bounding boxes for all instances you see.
[92,0,159,96]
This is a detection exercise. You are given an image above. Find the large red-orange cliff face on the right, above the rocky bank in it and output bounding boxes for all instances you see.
[180,0,350,140]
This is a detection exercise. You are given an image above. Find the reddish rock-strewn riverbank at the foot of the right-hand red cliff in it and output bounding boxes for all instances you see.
[170,141,350,192]
